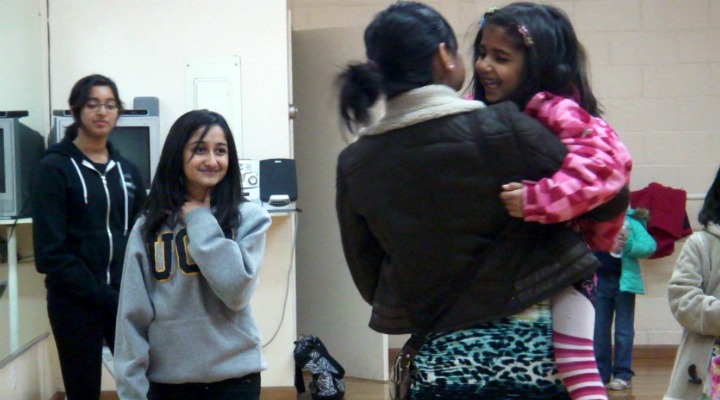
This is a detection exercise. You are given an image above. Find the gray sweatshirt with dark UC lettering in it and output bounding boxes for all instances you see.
[115,202,271,399]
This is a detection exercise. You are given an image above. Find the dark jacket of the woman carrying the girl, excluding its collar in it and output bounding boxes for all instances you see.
[336,87,599,334]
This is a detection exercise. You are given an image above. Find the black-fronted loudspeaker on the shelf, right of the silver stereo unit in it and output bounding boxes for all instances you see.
[260,158,298,207]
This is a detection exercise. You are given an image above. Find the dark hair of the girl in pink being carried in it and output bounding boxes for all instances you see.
[472,2,602,116]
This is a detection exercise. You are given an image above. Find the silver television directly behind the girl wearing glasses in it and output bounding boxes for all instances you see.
[48,110,162,189]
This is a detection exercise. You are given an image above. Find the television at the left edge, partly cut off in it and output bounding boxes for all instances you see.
[0,111,45,218]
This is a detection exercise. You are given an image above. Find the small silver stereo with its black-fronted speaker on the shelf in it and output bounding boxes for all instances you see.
[240,158,298,213]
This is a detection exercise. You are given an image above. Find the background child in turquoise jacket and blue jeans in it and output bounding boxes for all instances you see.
[595,208,657,390]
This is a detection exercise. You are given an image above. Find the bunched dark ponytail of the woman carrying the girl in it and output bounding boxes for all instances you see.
[338,62,385,132]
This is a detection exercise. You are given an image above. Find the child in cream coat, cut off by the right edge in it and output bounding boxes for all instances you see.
[663,166,720,400]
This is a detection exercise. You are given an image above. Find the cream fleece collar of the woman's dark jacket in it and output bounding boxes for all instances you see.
[360,85,485,136]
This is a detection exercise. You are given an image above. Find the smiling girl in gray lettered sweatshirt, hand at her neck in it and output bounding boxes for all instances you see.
[115,110,270,400]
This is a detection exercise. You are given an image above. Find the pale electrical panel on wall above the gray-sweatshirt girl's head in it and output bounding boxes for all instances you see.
[185,56,243,157]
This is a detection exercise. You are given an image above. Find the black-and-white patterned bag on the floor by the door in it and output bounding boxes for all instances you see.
[293,335,345,400]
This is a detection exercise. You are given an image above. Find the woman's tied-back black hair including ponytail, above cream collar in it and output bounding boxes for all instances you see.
[336,1,458,131]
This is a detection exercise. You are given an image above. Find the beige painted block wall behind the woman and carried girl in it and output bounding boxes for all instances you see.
[288,0,720,347]
